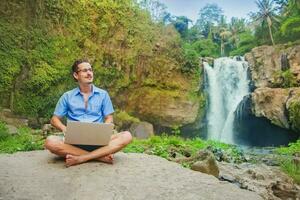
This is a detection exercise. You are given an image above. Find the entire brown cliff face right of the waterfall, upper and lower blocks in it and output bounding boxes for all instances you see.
[245,45,300,134]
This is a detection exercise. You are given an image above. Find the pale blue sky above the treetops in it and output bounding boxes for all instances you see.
[159,0,258,23]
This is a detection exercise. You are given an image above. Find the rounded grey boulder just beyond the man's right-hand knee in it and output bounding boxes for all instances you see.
[129,122,154,139]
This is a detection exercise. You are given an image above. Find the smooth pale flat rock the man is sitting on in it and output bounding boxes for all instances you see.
[0,151,262,200]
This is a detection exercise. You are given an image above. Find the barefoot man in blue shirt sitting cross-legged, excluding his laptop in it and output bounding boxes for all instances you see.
[45,60,132,166]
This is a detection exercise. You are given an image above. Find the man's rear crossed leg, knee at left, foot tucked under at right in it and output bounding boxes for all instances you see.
[45,135,114,163]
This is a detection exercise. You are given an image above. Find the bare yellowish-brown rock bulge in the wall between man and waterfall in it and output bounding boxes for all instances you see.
[116,87,200,128]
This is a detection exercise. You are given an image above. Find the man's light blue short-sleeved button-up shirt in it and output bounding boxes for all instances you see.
[54,85,114,122]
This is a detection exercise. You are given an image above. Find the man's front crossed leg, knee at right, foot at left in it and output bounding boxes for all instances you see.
[66,131,132,166]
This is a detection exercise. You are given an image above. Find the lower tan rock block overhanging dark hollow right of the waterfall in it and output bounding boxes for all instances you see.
[251,88,300,131]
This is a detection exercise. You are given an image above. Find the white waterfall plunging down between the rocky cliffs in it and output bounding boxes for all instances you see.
[203,57,250,144]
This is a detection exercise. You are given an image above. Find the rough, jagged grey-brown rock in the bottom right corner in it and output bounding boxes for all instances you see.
[219,163,300,200]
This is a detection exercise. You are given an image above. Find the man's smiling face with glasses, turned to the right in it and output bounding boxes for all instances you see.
[73,62,94,84]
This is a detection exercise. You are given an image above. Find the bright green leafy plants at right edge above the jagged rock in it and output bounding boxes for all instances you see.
[276,140,300,184]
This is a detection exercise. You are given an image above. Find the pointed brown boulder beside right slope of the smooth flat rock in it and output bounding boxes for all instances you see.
[191,150,219,178]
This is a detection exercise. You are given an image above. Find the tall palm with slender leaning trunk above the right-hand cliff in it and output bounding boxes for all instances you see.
[251,0,279,45]
